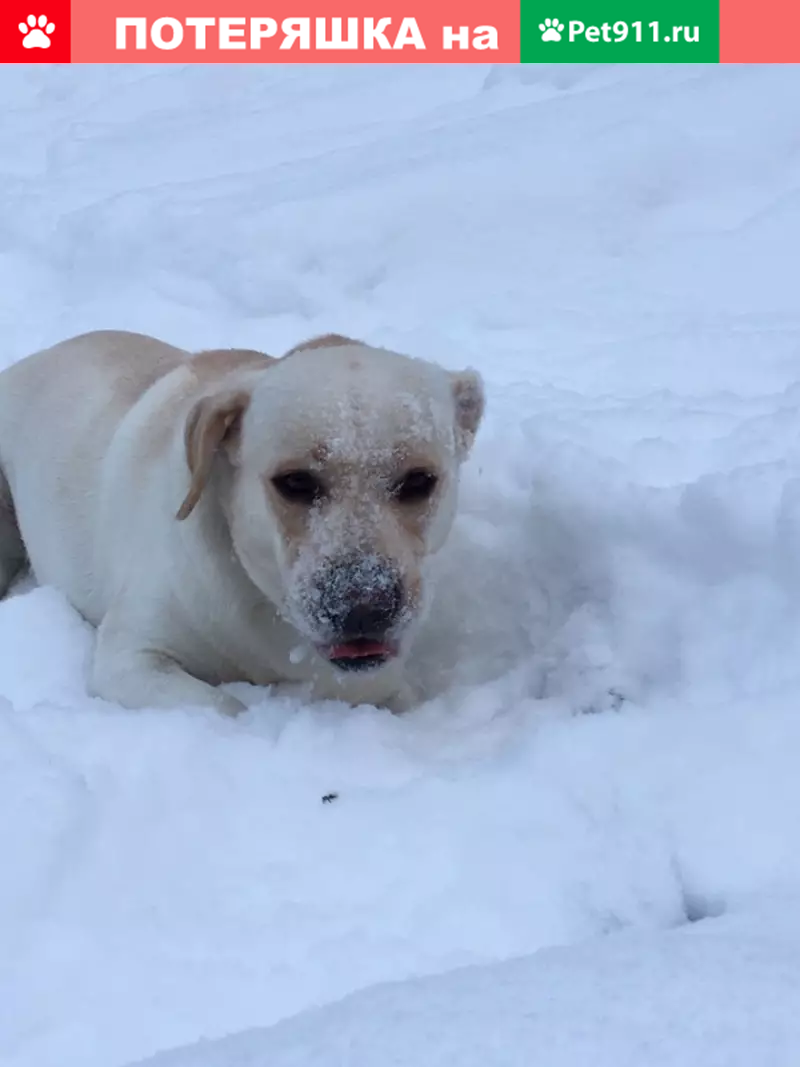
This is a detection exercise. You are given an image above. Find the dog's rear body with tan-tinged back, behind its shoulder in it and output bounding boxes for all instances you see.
[0,331,187,614]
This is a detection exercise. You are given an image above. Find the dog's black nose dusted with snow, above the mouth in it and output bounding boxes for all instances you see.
[317,556,403,639]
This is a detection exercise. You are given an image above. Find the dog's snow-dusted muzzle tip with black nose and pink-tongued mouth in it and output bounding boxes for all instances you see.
[313,555,404,671]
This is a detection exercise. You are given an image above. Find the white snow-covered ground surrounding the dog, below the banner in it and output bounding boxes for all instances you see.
[0,60,800,1067]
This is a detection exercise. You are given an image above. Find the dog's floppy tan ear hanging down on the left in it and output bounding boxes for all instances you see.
[175,389,250,521]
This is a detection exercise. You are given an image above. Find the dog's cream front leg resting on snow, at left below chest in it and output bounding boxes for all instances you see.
[90,621,245,716]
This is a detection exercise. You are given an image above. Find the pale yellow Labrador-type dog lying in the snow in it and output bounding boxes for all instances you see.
[0,331,484,715]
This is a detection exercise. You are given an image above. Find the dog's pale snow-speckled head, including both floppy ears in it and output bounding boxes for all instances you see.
[178,337,484,671]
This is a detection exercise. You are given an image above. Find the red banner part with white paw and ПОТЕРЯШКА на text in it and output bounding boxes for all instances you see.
[0,0,519,63]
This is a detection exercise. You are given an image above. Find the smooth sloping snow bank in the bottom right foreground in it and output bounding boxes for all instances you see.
[128,914,800,1067]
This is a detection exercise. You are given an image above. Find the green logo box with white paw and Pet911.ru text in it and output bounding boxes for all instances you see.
[519,0,719,63]
